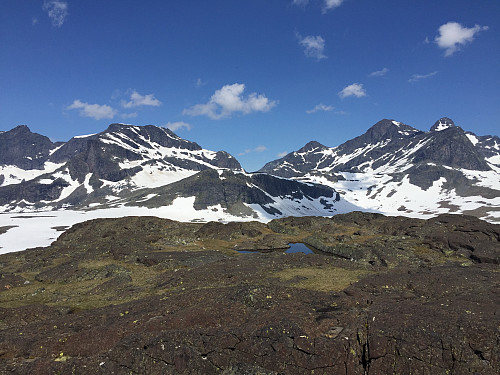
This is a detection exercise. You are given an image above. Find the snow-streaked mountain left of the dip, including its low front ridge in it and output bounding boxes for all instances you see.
[0,124,348,220]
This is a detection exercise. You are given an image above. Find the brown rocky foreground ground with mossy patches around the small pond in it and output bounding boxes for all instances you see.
[0,213,500,375]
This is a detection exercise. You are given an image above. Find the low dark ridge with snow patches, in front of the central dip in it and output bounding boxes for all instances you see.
[121,169,356,219]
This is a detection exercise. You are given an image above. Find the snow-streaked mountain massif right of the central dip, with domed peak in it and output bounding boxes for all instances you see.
[259,117,500,221]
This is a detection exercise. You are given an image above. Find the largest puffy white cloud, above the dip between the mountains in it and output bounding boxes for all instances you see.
[183,83,278,120]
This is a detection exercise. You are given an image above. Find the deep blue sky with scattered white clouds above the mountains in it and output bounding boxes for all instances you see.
[0,0,500,171]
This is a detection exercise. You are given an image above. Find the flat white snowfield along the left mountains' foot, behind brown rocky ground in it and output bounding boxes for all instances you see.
[0,194,352,254]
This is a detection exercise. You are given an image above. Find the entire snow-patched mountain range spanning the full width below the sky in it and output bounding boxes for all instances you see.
[0,117,500,222]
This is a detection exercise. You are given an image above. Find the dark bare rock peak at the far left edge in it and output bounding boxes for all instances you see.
[0,125,55,169]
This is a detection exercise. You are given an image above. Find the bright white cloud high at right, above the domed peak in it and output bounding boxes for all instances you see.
[434,22,488,56]
